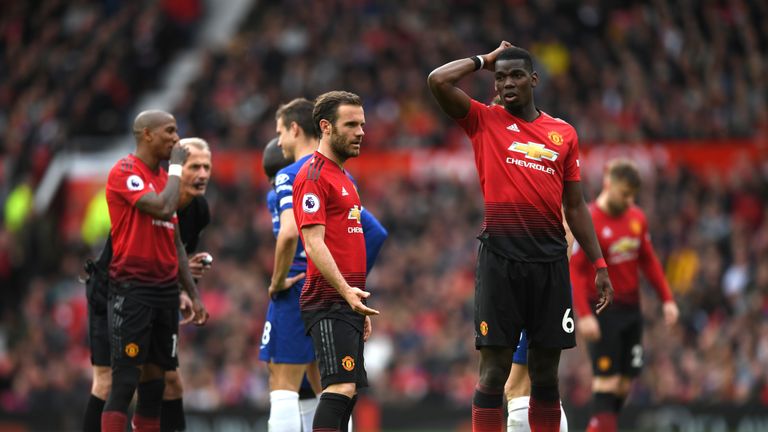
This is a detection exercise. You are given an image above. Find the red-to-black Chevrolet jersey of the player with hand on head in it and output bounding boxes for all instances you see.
[457,100,581,262]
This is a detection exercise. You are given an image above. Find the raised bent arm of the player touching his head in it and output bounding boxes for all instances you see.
[427,41,512,119]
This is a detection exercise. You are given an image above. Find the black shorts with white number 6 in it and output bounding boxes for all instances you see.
[475,244,576,349]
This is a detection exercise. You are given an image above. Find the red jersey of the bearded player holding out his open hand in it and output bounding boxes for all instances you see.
[293,152,365,311]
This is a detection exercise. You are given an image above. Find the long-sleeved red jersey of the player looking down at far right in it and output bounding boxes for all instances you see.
[570,203,672,316]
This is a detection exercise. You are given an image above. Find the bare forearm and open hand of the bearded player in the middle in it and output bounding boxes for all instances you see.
[301,225,379,315]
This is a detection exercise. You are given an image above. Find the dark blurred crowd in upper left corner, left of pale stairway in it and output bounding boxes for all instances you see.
[0,0,202,191]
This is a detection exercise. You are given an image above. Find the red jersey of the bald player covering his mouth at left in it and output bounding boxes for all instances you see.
[107,155,179,286]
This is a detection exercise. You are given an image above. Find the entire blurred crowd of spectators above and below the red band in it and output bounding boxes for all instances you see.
[0,0,768,426]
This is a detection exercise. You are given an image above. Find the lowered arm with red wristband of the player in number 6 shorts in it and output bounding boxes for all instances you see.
[563,181,613,314]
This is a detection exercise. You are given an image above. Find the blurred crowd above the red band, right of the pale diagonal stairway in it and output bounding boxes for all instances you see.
[177,0,768,153]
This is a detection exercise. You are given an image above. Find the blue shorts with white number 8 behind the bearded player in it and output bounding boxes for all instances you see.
[259,279,315,364]
